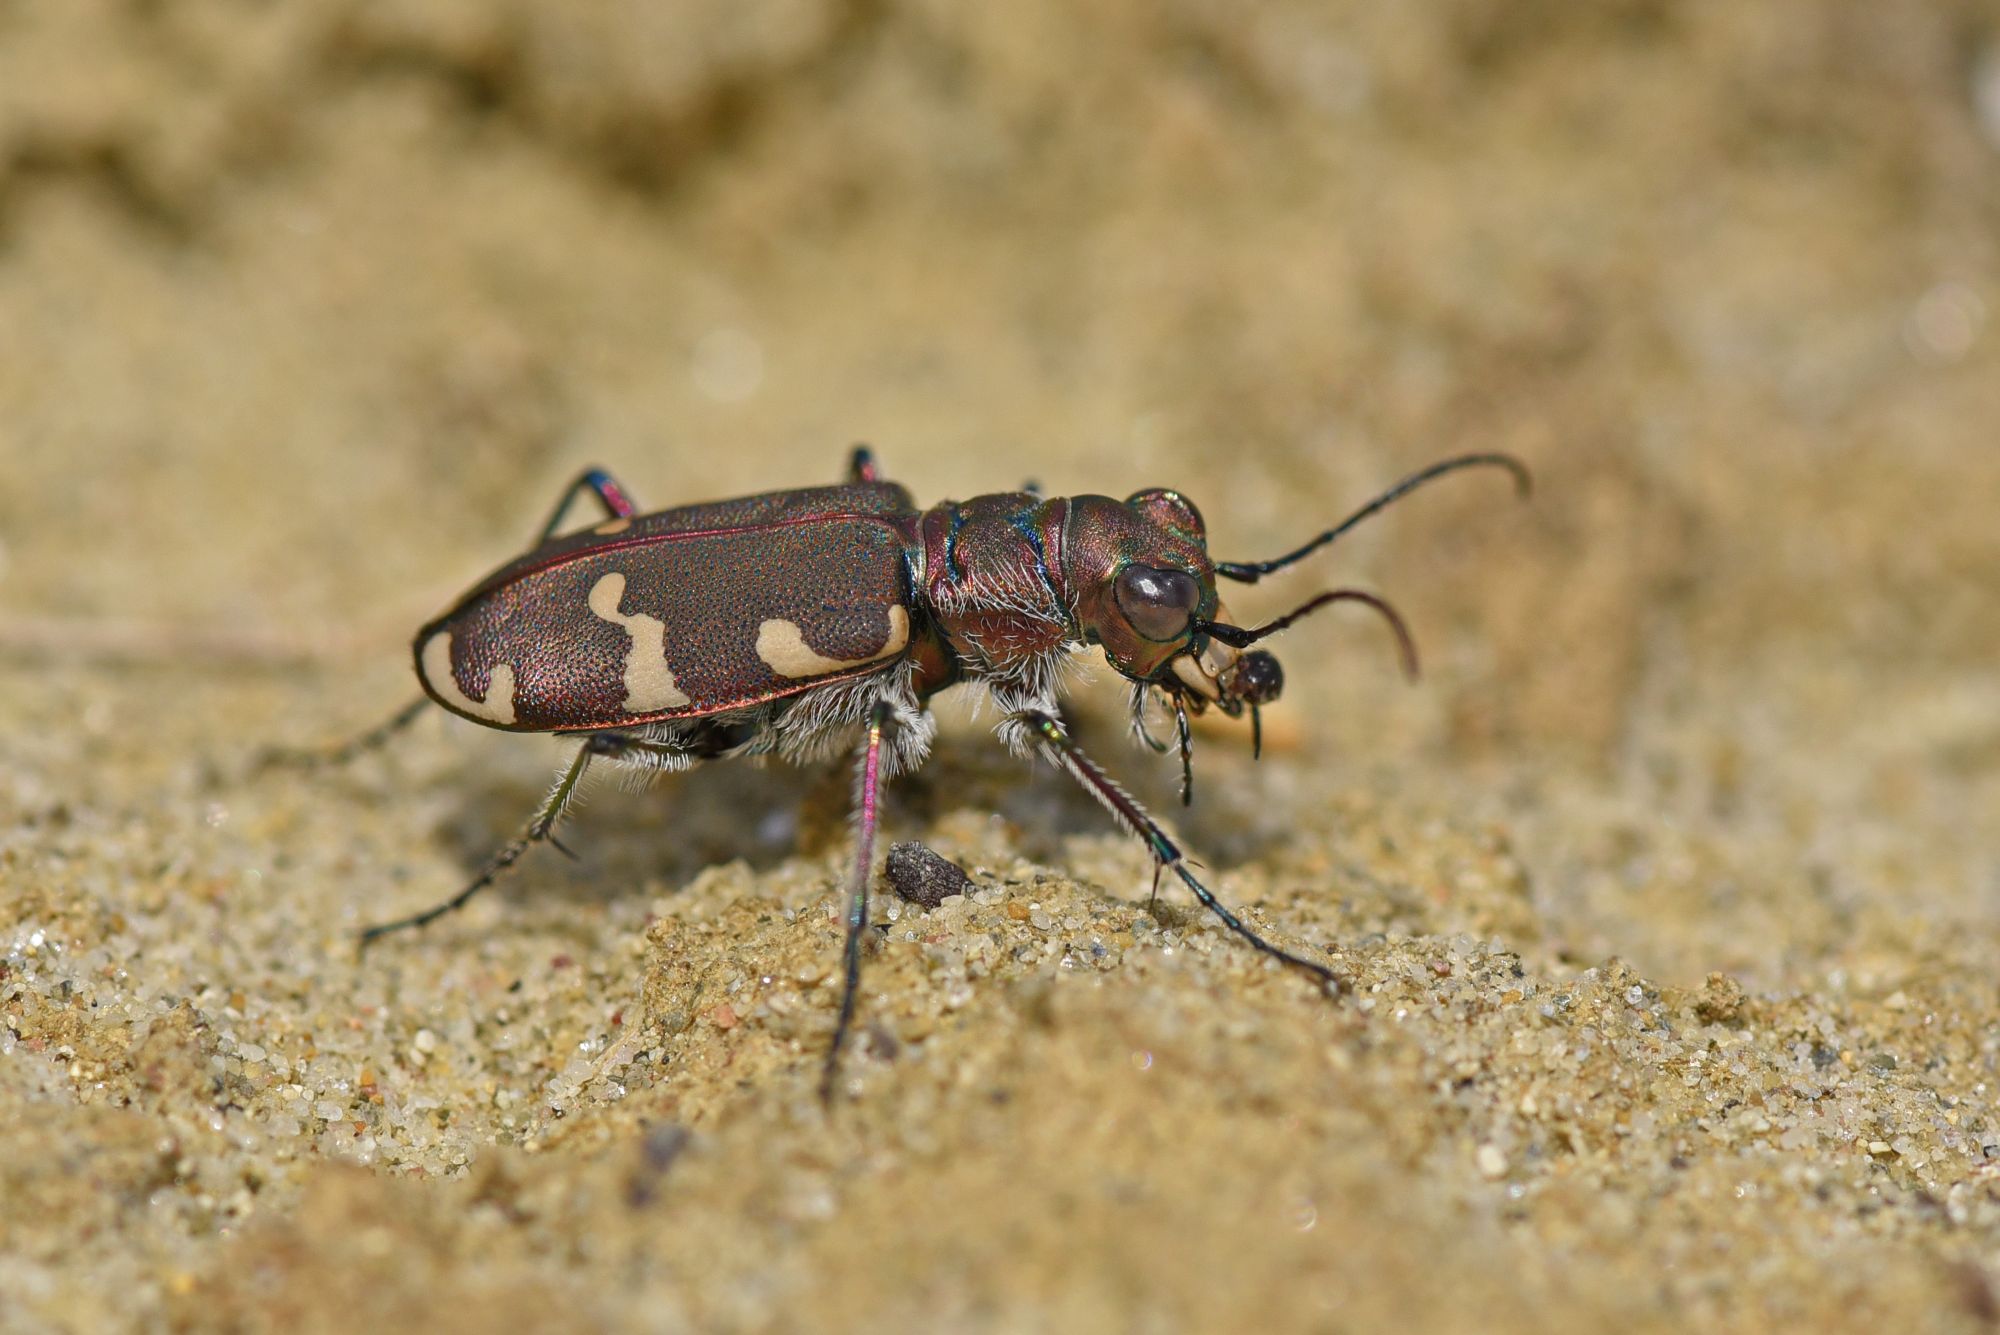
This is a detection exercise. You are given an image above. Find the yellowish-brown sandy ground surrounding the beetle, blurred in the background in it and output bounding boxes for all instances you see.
[0,0,2000,1331]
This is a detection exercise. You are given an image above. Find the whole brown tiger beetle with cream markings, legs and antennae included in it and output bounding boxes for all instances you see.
[286,448,1528,1099]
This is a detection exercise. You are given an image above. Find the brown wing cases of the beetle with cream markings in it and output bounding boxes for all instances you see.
[416,516,910,731]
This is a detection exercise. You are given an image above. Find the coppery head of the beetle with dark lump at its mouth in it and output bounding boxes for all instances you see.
[1064,488,1284,713]
